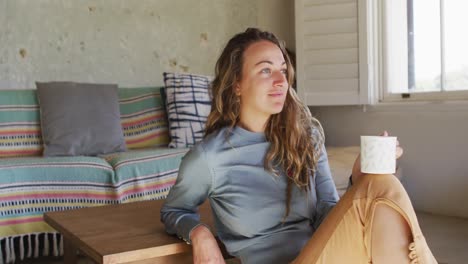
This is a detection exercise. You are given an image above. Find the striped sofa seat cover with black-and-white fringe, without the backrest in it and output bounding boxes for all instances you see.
[0,148,187,263]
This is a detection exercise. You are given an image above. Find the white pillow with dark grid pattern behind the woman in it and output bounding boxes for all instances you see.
[163,72,212,148]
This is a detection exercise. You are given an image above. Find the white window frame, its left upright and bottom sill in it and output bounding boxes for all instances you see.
[359,0,468,105]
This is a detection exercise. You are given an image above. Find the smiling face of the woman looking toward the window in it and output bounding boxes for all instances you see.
[236,40,289,121]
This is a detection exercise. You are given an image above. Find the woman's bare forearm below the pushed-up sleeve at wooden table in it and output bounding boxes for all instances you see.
[190,225,225,264]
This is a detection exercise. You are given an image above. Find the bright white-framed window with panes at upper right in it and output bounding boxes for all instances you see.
[367,0,468,101]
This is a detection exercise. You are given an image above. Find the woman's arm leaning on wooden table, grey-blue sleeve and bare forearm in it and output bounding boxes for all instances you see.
[161,145,224,263]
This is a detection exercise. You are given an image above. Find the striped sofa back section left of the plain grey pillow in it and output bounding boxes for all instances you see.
[0,90,43,158]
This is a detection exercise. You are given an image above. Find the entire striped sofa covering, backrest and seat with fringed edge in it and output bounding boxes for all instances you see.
[0,88,188,264]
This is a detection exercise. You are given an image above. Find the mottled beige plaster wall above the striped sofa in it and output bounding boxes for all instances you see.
[0,0,258,89]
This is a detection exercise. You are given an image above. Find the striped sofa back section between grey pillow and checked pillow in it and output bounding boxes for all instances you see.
[119,87,169,149]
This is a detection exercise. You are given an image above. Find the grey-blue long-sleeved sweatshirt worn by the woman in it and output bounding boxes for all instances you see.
[161,127,339,264]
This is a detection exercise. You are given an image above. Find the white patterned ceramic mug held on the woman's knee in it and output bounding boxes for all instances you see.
[361,136,397,174]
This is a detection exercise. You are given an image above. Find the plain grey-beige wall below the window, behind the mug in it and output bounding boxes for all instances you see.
[311,105,468,218]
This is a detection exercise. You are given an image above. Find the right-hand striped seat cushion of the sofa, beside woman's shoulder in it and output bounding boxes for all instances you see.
[103,147,188,203]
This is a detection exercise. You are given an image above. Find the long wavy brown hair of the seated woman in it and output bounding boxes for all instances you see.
[205,28,324,217]
